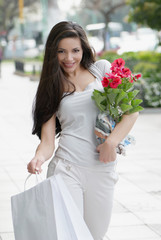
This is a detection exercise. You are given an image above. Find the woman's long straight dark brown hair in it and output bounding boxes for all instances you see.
[32,21,95,139]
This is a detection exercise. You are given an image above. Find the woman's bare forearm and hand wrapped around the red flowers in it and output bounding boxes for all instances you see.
[97,112,139,163]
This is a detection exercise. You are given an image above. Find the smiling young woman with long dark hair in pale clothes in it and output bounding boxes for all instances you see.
[28,22,138,240]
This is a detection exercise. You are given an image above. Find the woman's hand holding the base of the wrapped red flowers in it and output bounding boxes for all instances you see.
[97,140,116,163]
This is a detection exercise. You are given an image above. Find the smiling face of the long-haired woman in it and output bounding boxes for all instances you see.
[58,38,83,74]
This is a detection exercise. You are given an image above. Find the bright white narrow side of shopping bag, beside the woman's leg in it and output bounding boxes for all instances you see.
[51,175,93,240]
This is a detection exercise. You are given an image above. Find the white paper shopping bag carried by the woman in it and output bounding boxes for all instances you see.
[11,175,93,240]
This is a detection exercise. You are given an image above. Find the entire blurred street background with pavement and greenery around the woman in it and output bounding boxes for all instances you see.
[0,0,161,240]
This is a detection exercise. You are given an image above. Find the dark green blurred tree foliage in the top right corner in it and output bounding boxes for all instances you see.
[128,0,161,31]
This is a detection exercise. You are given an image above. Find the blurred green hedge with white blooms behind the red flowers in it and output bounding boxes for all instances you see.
[97,51,161,107]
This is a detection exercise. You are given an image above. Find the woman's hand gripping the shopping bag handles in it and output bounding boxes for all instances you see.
[27,156,45,174]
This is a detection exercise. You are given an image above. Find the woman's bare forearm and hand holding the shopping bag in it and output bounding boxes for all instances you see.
[27,115,56,174]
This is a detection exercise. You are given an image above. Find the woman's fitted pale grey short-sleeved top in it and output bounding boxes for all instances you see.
[55,60,115,166]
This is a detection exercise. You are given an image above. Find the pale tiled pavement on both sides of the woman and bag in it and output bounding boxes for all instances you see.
[0,63,161,240]
